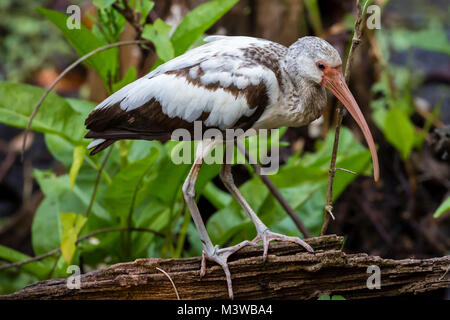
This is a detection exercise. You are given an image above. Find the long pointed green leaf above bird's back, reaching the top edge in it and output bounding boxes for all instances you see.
[171,0,239,56]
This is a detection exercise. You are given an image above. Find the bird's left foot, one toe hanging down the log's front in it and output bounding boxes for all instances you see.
[200,240,252,299]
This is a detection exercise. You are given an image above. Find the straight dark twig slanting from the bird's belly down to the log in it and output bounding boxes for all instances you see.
[236,141,311,238]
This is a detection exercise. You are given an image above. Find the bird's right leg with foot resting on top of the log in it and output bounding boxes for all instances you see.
[220,164,314,261]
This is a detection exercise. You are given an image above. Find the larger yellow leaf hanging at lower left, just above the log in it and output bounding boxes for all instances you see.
[61,212,87,264]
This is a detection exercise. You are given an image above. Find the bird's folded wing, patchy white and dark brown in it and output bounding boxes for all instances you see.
[86,37,286,152]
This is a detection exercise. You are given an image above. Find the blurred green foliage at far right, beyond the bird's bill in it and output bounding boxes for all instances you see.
[371,24,450,217]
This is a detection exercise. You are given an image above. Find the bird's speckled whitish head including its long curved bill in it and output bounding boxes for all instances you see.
[286,37,379,181]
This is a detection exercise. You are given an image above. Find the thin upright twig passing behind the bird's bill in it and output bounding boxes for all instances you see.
[320,0,369,235]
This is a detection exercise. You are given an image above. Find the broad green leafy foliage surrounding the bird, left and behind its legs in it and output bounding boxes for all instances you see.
[0,0,370,292]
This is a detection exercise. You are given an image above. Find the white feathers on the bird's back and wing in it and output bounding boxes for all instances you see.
[94,37,280,130]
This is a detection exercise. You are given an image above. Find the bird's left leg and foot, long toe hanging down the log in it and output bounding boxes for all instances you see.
[183,145,251,299]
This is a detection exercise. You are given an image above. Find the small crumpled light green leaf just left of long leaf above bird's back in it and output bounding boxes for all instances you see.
[142,19,175,62]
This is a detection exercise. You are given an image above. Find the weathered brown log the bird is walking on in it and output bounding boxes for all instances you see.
[0,235,450,300]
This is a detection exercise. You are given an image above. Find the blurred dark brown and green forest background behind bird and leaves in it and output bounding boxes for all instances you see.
[0,0,450,294]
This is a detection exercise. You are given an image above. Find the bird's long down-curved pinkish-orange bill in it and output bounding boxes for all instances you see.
[322,67,380,181]
